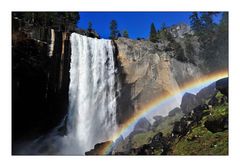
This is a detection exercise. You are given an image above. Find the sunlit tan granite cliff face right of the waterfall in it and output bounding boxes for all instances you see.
[115,38,201,123]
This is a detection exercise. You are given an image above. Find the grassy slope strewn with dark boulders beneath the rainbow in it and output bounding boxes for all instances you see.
[109,77,228,155]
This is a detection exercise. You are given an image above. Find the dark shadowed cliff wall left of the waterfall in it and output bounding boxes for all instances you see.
[12,18,71,142]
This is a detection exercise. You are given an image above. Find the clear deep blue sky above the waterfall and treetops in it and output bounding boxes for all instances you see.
[78,12,220,39]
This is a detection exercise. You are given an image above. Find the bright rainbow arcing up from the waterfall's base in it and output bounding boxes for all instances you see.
[99,69,228,155]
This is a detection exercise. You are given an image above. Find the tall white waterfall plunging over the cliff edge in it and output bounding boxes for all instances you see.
[62,33,117,154]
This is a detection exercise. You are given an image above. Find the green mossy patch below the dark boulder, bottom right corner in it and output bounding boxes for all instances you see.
[171,126,228,155]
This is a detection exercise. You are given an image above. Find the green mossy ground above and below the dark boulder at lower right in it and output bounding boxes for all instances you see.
[171,92,228,155]
